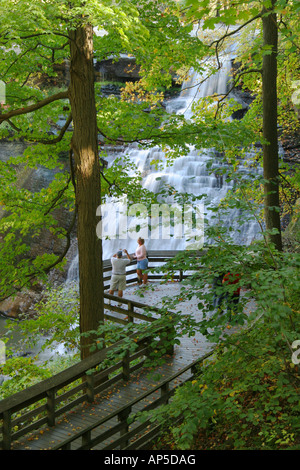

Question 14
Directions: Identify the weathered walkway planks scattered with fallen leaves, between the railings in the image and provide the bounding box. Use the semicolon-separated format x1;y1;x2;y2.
6;283;213;450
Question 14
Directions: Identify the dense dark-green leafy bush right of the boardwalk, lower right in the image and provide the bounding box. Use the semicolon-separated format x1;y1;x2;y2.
141;244;300;449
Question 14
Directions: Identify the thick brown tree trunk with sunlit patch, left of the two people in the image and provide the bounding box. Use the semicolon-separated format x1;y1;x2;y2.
69;24;103;359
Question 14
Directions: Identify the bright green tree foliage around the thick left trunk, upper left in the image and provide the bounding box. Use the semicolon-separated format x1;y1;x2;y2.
0;0;211;299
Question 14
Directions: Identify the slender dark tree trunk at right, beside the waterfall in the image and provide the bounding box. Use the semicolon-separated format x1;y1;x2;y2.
262;0;282;251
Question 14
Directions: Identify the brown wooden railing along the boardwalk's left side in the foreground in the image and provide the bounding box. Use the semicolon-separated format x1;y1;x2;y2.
0;322;173;450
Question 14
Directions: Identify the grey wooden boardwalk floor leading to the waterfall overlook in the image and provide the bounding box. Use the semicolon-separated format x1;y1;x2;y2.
7;285;213;450
